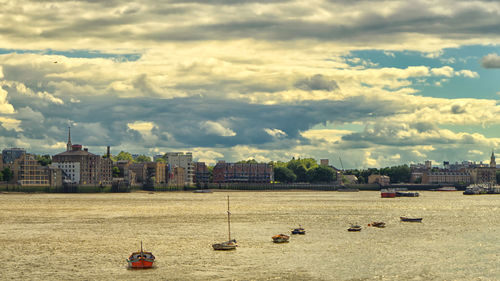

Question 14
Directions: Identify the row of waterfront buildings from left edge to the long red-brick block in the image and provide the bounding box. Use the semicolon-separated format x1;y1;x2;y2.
0;144;274;186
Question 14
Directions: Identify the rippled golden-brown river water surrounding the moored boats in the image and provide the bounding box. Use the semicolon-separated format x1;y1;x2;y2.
0;189;500;280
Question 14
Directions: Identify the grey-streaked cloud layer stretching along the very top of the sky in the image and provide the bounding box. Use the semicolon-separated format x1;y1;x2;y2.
2;0;500;46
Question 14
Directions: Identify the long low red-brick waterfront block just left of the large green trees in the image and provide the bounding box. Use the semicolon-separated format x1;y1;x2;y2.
213;161;274;183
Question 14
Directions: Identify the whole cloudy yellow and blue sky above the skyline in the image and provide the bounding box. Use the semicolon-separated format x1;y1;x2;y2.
0;0;500;168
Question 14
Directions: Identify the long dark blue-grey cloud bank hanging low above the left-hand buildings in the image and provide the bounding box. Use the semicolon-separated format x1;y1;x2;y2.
0;89;402;153
